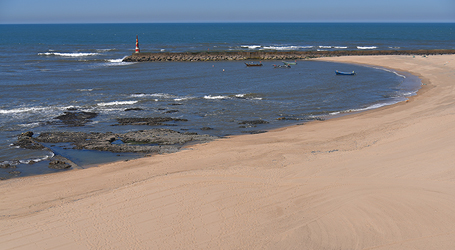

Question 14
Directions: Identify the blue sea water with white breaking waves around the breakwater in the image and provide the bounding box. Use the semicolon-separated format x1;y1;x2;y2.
0;23;455;178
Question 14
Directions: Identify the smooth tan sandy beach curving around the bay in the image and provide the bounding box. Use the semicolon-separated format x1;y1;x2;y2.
0;55;455;249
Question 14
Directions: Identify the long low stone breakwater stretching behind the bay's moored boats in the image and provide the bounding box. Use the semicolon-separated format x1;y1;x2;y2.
123;49;455;62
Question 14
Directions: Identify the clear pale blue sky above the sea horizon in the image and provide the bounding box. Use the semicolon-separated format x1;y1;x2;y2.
0;0;455;24
